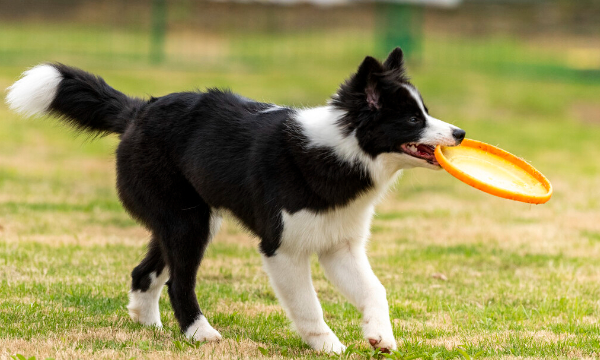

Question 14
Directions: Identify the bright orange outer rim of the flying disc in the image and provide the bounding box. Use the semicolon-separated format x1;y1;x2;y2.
434;139;553;204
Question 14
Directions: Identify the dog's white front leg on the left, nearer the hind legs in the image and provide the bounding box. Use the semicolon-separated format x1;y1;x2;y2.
263;252;346;353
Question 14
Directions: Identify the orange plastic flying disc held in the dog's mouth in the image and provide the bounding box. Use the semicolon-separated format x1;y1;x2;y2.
435;139;552;204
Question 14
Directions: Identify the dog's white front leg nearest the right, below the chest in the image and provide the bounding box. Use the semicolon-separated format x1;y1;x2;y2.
319;241;396;351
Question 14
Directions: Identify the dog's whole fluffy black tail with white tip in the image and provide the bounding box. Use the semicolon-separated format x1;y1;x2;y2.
6;64;147;134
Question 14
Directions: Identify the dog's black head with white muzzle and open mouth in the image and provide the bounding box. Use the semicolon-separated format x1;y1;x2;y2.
331;48;465;169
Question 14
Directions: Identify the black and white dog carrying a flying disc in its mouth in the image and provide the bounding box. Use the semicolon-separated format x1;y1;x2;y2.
6;48;465;353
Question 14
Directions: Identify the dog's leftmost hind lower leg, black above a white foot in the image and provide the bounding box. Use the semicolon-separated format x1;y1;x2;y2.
127;238;169;327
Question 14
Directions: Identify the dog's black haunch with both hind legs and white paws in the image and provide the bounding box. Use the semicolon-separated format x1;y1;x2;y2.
117;142;221;341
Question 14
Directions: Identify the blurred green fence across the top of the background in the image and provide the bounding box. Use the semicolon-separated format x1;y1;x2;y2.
0;0;600;81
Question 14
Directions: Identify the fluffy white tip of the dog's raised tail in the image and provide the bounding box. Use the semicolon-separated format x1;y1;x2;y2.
6;64;62;116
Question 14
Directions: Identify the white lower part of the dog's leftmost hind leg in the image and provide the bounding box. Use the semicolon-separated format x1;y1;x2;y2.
127;267;169;327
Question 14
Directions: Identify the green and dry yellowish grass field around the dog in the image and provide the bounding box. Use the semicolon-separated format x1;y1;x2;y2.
0;26;600;359
